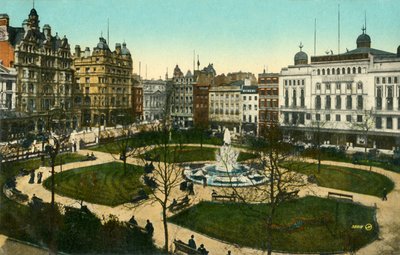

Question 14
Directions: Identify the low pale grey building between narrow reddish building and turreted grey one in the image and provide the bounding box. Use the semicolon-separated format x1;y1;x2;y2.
142;79;167;121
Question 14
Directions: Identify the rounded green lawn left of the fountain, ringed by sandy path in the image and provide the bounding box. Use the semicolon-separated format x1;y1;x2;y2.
43;162;147;206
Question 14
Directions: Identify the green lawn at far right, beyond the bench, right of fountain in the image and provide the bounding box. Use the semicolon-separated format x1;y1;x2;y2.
288;162;394;197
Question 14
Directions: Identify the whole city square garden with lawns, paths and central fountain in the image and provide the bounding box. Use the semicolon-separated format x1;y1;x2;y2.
0;126;400;254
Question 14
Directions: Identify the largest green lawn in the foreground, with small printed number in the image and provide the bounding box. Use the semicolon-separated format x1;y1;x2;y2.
169;197;378;253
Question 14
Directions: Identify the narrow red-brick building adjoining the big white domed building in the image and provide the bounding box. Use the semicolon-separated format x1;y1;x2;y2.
258;72;279;134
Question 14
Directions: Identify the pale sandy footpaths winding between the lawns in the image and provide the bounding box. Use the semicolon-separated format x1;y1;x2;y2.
8;145;400;255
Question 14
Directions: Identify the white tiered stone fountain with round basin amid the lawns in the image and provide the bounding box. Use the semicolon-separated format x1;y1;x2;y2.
184;128;266;187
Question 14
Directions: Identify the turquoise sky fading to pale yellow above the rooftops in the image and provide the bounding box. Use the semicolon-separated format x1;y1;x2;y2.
0;0;400;79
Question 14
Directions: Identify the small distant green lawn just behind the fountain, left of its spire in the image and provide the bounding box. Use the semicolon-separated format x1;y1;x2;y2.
147;146;217;163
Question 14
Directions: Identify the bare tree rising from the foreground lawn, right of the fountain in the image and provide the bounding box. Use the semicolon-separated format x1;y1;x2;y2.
227;126;307;254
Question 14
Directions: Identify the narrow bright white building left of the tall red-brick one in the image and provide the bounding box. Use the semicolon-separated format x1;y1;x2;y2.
240;79;258;135
